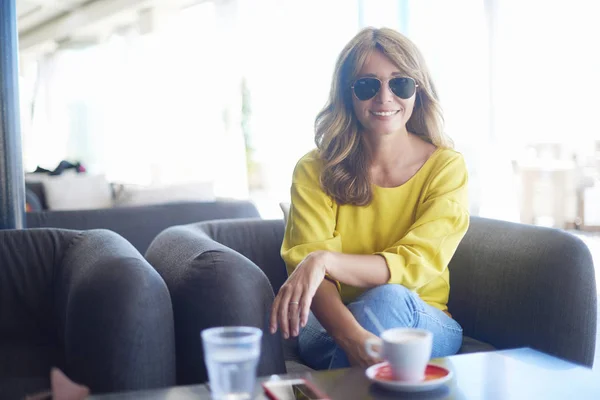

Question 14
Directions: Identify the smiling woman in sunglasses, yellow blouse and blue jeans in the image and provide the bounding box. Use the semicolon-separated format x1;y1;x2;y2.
270;28;469;369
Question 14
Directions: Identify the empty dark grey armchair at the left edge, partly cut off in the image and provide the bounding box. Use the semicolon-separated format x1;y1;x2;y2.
0;229;175;399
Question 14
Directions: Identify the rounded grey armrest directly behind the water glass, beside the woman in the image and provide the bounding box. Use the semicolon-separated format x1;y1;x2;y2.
146;224;285;385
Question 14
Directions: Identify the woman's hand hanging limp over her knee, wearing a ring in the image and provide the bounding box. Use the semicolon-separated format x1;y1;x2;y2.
270;251;327;339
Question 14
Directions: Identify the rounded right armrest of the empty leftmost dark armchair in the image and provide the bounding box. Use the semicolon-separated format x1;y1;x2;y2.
55;230;175;392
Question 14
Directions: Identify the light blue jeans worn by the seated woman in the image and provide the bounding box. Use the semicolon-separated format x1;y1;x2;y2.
298;284;462;369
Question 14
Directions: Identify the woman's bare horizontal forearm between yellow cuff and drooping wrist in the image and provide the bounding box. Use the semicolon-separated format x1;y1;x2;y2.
322;251;390;288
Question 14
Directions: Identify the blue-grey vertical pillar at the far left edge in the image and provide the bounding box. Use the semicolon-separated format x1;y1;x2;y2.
0;0;25;229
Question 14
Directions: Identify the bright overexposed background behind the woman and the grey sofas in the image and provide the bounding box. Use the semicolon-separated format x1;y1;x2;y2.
17;0;600;225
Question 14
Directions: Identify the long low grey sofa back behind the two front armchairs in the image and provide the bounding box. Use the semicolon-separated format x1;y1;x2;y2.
27;200;260;254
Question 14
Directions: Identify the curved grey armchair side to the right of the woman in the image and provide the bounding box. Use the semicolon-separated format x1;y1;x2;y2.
449;217;597;366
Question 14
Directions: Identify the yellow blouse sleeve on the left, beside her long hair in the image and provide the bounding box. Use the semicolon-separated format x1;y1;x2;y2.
281;155;342;290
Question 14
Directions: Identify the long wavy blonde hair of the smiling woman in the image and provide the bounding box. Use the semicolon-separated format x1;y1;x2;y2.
315;28;452;206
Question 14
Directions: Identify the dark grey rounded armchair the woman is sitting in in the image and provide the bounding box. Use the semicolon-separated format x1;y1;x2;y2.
146;217;597;384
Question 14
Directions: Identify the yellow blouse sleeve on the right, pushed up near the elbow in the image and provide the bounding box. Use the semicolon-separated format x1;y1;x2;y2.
375;154;469;290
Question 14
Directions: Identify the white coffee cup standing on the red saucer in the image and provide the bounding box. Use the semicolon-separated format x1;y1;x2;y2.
365;328;433;382
